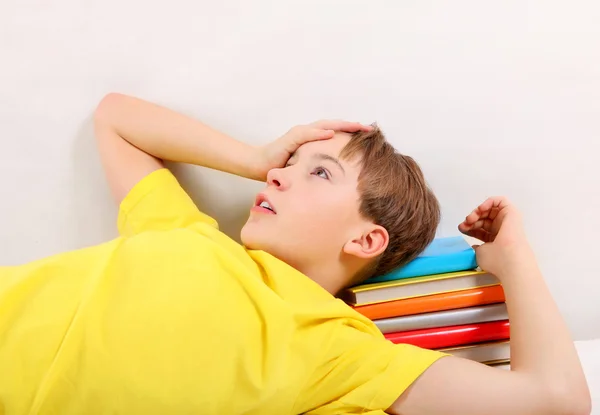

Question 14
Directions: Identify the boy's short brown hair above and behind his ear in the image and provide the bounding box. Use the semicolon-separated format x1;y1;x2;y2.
340;124;441;284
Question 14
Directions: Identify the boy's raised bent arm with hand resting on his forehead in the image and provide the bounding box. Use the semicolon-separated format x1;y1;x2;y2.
94;93;371;206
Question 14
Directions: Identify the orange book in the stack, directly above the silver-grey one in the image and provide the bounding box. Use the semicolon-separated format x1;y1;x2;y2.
354;285;504;320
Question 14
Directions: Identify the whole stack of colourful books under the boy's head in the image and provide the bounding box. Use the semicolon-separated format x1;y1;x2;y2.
341;236;510;369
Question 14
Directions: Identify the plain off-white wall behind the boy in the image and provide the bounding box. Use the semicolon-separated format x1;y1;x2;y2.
0;0;600;339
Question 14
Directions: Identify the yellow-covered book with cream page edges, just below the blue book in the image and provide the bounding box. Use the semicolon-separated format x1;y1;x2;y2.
340;270;500;305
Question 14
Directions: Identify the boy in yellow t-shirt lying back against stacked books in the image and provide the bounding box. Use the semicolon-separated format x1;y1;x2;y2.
0;94;590;415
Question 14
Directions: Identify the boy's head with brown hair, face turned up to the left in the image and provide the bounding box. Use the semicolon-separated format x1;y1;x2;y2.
241;127;440;292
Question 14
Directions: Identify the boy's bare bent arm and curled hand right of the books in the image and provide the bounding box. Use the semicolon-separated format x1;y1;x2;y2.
389;198;591;415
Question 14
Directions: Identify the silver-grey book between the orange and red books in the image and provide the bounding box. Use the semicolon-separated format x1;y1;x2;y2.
373;303;508;333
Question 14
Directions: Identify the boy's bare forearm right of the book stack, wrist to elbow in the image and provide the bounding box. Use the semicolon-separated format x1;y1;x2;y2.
503;247;589;406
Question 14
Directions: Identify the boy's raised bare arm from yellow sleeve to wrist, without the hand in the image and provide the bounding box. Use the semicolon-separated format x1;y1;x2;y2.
94;93;255;206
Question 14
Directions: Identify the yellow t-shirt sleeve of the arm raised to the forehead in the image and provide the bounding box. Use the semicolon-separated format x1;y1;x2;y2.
117;168;218;236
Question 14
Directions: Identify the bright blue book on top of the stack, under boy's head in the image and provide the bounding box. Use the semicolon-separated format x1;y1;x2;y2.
366;236;477;284
